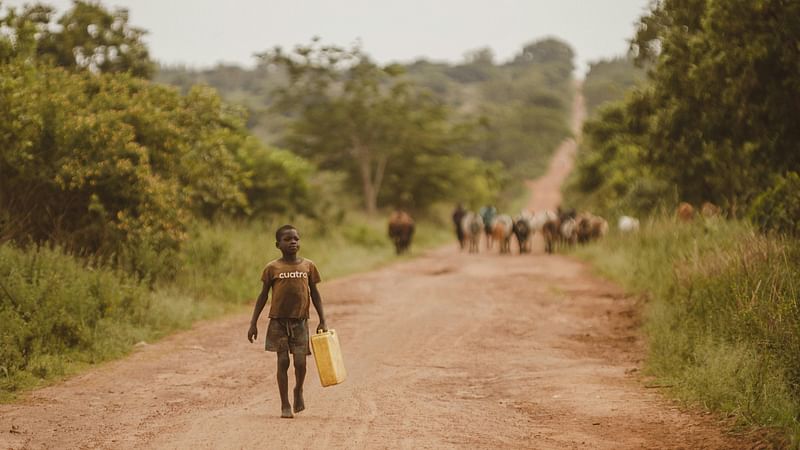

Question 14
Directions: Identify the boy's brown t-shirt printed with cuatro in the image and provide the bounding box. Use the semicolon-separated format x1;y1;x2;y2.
261;258;320;319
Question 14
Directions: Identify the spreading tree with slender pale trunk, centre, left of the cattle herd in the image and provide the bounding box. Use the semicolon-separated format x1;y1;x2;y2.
259;39;478;213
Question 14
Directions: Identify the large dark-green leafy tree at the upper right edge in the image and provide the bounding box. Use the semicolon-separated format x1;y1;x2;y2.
568;0;800;222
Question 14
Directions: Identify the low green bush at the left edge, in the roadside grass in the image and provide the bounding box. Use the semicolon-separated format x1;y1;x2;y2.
0;243;150;390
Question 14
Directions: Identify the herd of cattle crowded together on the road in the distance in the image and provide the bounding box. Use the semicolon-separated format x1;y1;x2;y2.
460;207;608;254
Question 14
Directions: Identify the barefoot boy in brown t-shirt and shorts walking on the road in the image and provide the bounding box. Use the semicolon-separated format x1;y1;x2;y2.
247;225;328;419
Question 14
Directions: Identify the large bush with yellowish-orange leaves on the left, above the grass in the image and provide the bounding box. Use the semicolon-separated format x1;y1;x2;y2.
0;62;253;276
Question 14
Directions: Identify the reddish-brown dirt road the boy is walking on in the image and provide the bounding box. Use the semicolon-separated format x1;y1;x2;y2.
0;89;738;449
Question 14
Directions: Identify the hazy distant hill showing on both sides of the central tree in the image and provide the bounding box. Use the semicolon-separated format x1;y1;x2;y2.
155;38;574;178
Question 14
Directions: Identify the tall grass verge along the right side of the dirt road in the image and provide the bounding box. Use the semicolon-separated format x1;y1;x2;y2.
577;218;800;446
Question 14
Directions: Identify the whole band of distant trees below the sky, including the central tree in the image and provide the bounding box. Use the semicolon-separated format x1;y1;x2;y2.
156;39;574;204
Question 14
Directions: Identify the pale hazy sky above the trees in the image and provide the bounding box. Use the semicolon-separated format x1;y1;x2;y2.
0;0;650;76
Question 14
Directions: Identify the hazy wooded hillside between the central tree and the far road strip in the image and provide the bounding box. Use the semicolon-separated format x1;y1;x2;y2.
407;39;574;179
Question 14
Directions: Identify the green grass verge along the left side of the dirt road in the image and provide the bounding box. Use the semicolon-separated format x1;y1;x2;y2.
0;213;455;401
